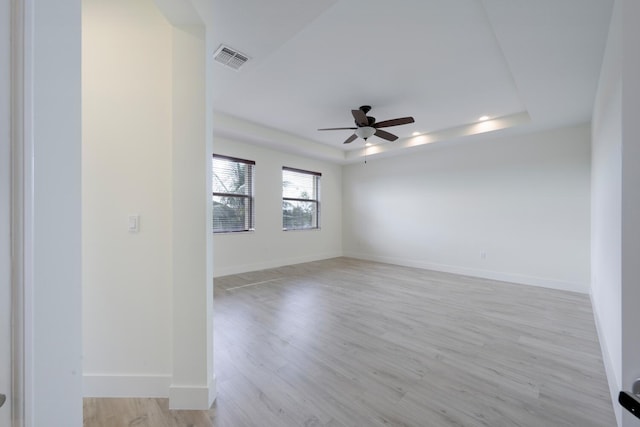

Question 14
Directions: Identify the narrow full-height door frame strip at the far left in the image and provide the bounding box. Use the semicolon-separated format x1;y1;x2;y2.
10;0;34;427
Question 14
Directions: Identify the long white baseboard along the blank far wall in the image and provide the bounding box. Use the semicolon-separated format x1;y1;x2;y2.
344;252;589;294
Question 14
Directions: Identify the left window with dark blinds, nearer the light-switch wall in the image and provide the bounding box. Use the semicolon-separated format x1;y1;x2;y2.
212;154;256;233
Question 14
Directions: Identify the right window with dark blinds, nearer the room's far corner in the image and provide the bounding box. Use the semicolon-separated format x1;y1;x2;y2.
282;167;322;230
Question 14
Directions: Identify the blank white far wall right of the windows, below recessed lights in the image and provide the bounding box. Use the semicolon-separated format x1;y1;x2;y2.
343;126;590;292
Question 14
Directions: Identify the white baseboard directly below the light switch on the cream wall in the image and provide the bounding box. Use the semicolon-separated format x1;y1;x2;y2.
82;374;171;397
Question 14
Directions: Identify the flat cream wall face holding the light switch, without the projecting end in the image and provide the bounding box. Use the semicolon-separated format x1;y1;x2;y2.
82;0;172;397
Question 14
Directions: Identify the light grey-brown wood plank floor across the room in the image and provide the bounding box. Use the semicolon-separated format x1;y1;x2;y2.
84;258;615;427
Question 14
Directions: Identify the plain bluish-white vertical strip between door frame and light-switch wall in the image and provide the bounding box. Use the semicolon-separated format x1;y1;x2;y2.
32;0;82;426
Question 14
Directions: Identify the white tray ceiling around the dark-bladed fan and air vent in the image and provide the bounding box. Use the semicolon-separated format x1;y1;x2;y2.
213;0;612;161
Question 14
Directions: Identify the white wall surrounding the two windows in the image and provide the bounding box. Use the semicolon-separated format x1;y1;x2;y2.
213;137;342;276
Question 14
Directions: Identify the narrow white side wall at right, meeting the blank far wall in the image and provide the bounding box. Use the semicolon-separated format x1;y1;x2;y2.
591;2;622;421
